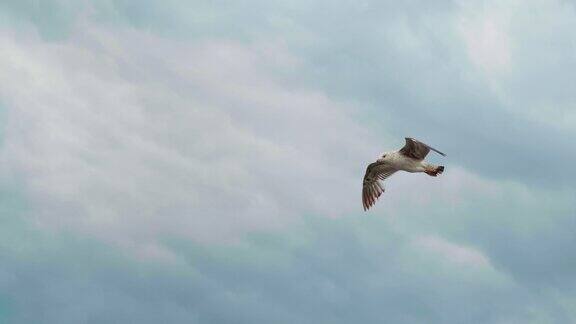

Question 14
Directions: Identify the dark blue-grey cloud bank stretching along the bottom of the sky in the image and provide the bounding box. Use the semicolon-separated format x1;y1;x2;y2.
0;208;567;323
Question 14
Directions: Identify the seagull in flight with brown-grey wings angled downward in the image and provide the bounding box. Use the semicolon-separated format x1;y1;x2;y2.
362;137;446;211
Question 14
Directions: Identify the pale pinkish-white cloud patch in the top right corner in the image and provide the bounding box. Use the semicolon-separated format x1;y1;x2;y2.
457;0;576;131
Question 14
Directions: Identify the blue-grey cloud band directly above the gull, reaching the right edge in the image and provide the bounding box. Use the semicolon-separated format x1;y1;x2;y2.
288;0;576;187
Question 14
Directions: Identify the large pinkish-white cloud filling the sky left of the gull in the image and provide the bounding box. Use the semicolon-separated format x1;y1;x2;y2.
0;26;372;250
